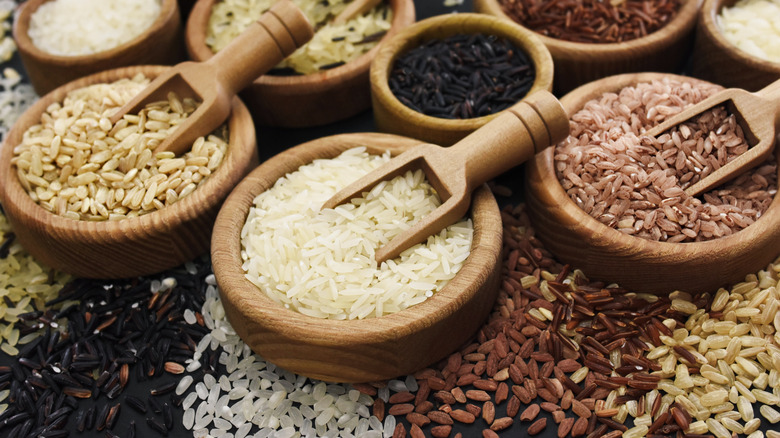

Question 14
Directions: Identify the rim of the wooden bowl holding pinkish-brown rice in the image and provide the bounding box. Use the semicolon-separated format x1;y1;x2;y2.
530;72;780;258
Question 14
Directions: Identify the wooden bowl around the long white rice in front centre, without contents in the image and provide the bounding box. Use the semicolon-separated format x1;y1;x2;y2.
211;133;501;382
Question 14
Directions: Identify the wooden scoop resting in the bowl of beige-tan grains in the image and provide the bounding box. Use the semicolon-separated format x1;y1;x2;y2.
111;0;314;155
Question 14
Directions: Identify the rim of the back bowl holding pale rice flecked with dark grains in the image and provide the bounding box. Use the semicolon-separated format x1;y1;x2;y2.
185;0;415;94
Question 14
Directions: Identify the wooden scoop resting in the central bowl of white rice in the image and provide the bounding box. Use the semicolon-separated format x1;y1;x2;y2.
323;91;569;263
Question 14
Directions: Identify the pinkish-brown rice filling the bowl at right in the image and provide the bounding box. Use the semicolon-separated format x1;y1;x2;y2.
555;78;777;242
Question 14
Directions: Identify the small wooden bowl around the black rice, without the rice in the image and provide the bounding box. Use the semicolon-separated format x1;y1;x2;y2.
371;13;553;146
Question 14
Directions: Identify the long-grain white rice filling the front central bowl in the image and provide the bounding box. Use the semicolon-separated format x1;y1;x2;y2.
241;148;473;319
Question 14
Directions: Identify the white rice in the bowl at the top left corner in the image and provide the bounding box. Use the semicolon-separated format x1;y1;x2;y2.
28;0;161;56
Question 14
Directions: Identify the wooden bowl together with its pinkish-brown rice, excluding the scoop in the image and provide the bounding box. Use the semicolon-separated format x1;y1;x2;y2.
526;73;780;293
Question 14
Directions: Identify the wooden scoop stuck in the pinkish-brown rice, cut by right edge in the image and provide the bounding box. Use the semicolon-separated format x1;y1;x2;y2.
645;80;780;196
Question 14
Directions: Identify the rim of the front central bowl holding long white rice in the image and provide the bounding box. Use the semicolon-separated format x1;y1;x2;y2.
211;133;502;348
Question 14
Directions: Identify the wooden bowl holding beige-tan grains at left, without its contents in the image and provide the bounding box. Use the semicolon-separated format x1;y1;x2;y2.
0;66;259;278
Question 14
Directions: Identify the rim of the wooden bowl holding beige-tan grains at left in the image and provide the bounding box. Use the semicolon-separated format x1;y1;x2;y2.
0;65;254;248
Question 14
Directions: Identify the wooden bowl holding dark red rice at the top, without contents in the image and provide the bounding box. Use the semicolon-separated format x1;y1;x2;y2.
474;0;699;95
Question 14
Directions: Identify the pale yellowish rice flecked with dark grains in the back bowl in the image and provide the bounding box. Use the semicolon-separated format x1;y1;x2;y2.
206;0;392;74
